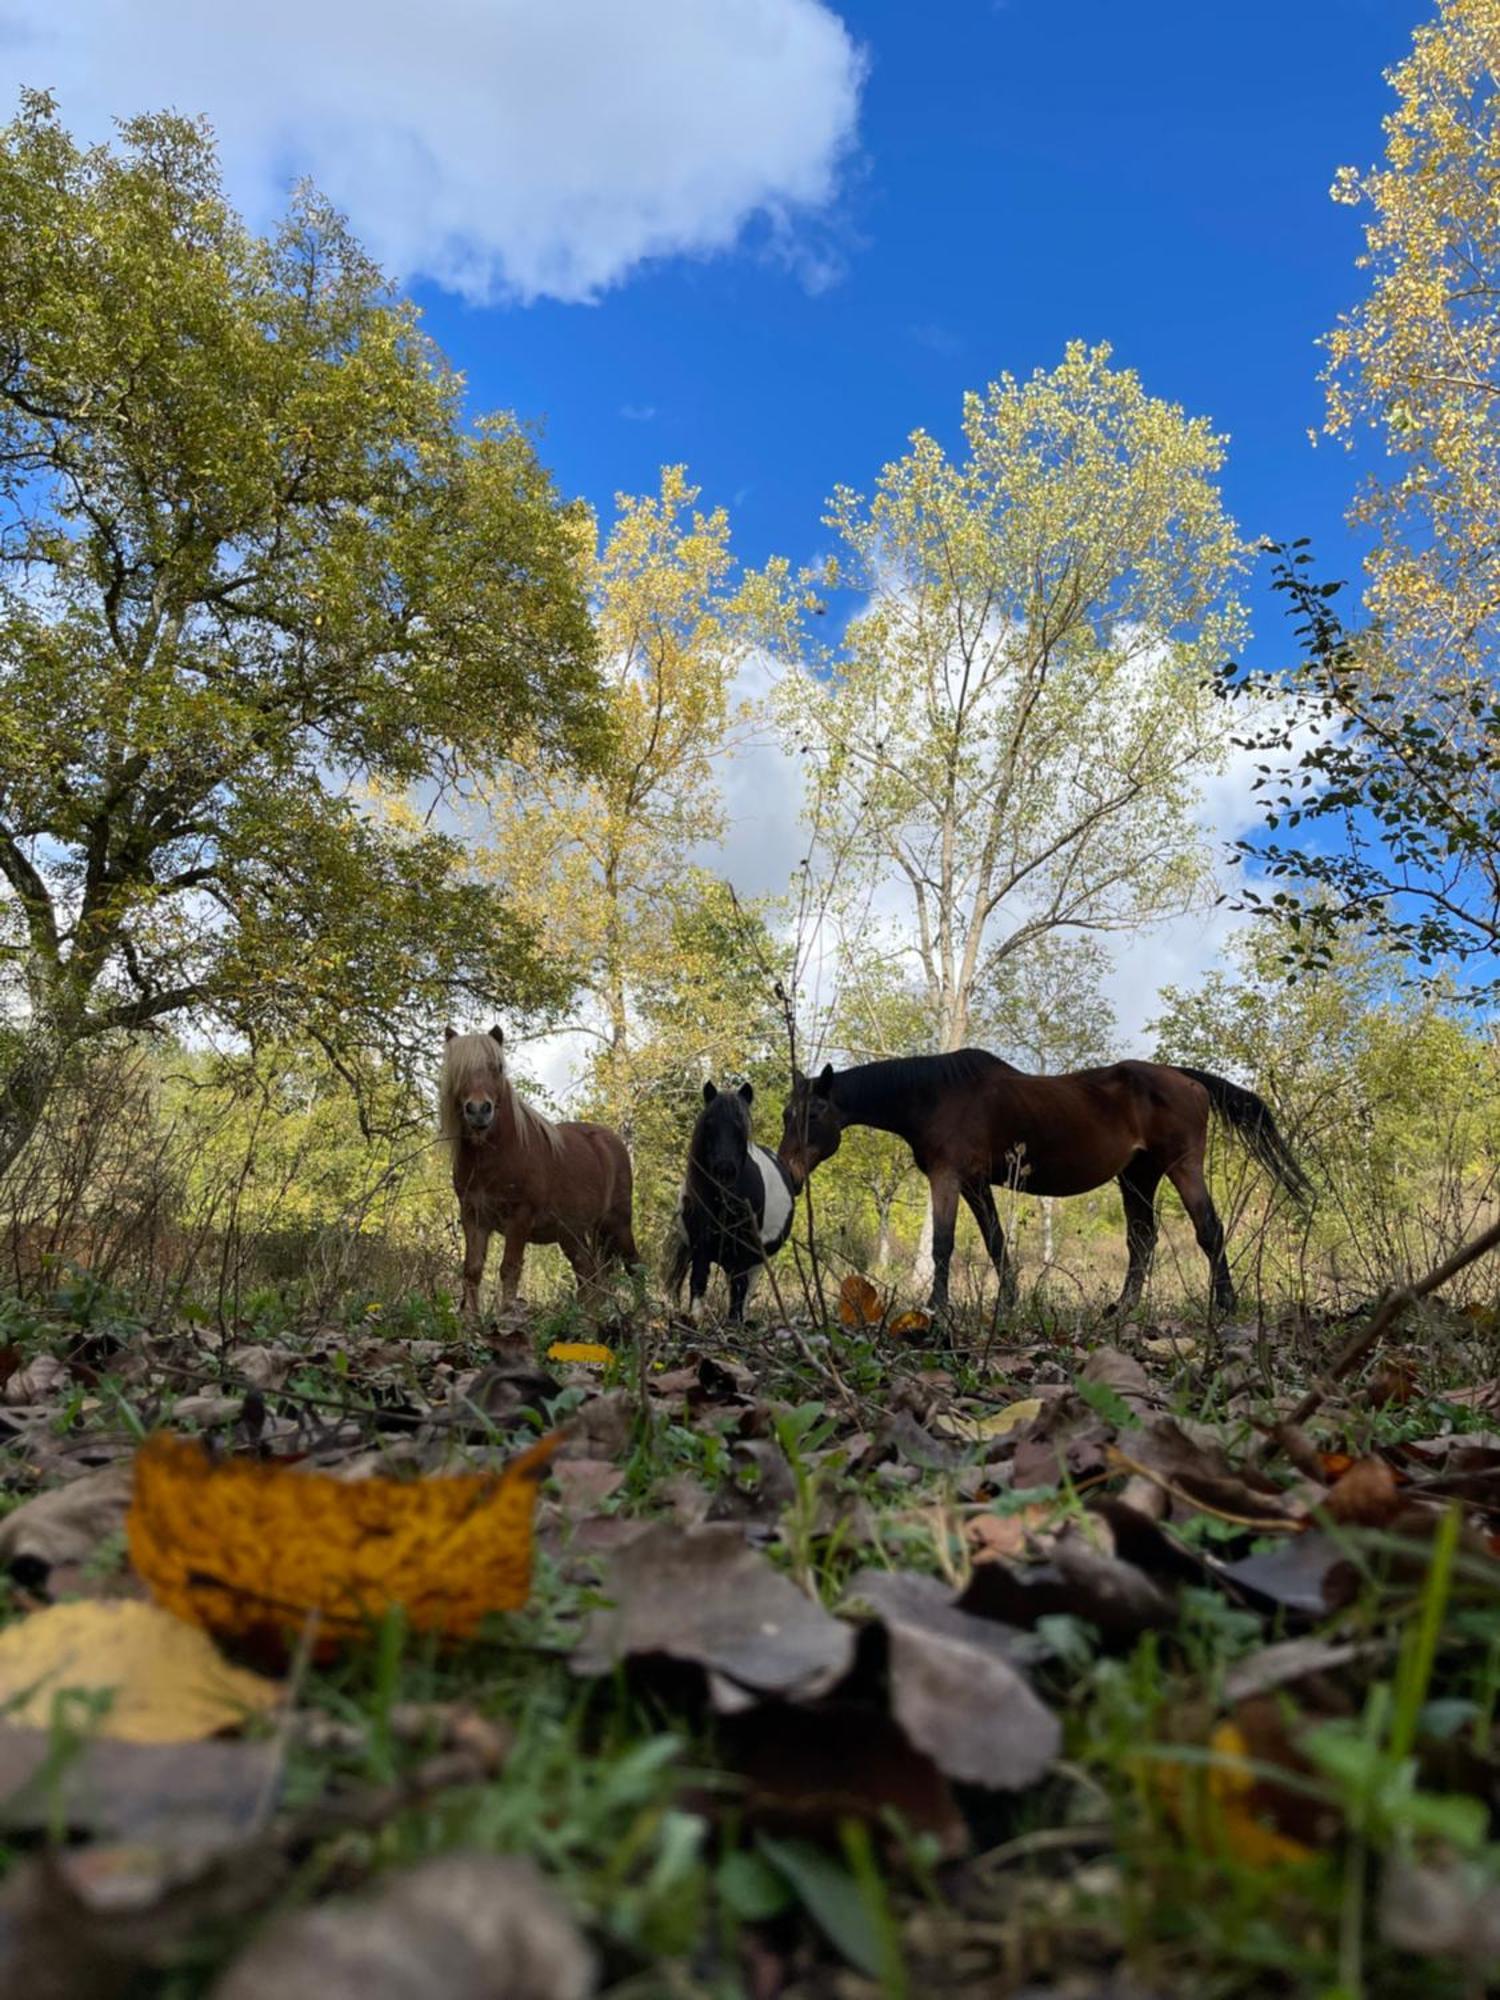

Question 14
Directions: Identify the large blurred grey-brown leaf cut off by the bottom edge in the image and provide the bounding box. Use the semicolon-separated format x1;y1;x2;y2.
214;1854;594;2000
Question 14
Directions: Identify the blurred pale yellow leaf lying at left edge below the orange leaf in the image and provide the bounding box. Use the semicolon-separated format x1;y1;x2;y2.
0;1598;282;1744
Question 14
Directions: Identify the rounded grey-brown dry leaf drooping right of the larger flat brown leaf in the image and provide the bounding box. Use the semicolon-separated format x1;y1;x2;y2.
850;1570;1062;1792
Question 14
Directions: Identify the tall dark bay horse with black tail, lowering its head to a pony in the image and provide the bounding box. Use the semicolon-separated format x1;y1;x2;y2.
780;1048;1308;1312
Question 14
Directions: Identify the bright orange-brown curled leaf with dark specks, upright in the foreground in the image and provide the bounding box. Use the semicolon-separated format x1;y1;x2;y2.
126;1434;560;1644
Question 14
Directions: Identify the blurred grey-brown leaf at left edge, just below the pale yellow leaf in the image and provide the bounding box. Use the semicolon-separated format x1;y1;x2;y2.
0;1724;282;1844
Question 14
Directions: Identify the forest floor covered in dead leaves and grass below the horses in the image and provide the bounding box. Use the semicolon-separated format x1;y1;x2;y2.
0;1278;1500;2000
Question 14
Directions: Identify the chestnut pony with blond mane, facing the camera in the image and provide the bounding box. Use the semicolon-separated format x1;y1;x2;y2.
438;1028;640;1314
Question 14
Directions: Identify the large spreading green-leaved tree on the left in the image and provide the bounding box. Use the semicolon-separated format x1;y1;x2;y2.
0;96;604;1168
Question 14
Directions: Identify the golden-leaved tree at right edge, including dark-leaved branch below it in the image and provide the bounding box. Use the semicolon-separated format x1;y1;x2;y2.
1232;0;1500;1000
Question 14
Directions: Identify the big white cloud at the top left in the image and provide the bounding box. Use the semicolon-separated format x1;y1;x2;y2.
0;0;864;300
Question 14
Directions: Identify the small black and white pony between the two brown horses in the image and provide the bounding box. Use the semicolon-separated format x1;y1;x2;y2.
666;1084;796;1320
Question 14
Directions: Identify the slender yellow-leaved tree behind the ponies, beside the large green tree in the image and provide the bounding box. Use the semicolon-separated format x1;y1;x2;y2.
484;466;788;1184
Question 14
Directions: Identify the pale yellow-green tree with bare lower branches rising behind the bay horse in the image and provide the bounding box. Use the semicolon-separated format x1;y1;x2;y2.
772;344;1240;1048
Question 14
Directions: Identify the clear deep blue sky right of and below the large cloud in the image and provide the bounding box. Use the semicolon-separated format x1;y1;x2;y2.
418;0;1430;664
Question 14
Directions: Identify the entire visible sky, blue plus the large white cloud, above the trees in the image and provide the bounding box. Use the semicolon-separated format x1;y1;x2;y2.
0;0;1432;1056
